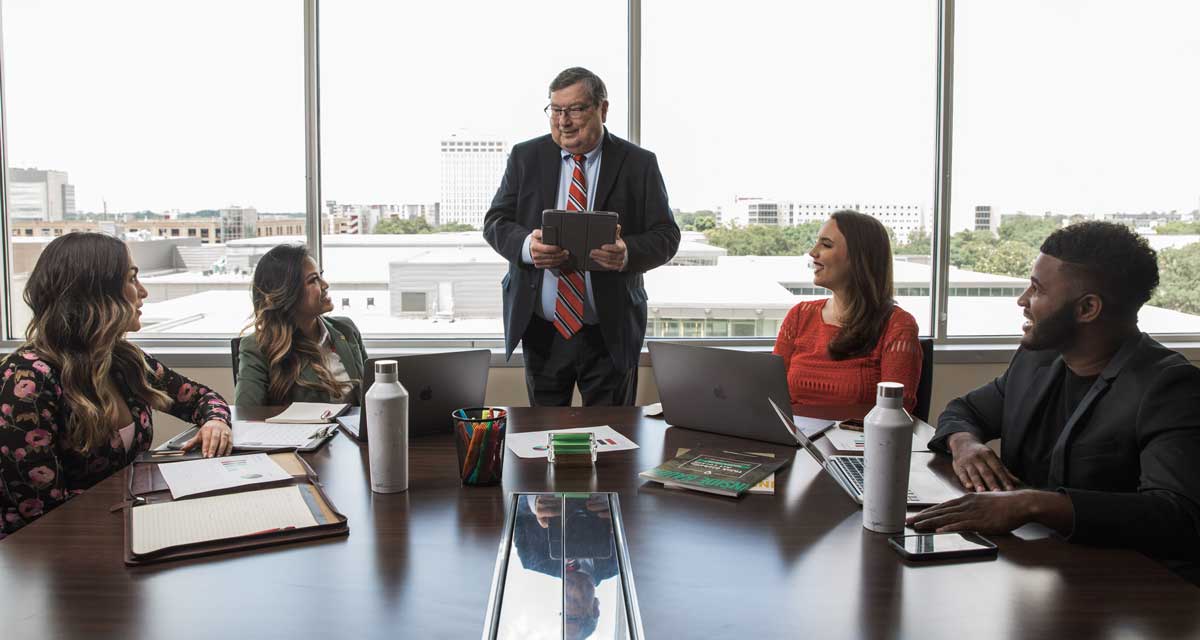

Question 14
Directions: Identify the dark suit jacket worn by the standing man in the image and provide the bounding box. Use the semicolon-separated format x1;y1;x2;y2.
484;130;679;369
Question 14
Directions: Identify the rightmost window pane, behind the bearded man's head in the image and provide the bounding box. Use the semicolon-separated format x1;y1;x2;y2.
948;0;1200;335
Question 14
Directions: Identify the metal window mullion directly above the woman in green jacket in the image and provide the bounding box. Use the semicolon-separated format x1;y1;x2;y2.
304;0;324;268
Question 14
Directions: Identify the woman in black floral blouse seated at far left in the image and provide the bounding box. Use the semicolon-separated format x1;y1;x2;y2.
0;233;233;539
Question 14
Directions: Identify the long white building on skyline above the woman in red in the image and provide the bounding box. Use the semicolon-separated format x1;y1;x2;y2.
718;197;928;243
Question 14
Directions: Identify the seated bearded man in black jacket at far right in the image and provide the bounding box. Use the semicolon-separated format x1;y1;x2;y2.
908;222;1200;584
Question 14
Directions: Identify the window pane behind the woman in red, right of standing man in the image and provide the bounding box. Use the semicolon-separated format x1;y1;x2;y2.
641;0;937;337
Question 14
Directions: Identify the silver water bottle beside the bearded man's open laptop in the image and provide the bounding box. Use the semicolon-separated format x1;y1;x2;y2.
863;382;912;533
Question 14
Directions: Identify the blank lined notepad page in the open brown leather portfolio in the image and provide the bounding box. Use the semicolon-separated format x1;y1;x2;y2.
130;485;317;554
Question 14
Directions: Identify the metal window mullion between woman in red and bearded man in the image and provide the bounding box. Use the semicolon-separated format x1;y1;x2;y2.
930;0;954;341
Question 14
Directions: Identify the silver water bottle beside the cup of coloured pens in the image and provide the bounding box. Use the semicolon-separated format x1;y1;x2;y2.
362;360;408;494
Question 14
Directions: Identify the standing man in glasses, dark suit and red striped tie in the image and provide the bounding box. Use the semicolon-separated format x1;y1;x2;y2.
484;67;679;406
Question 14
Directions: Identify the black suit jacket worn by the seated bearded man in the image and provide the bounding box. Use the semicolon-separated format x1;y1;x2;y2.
930;334;1200;581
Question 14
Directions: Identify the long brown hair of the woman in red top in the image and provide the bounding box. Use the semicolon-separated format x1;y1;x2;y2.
829;210;895;360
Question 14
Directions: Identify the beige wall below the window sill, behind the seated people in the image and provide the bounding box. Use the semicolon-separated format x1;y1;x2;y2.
145;363;1027;445
